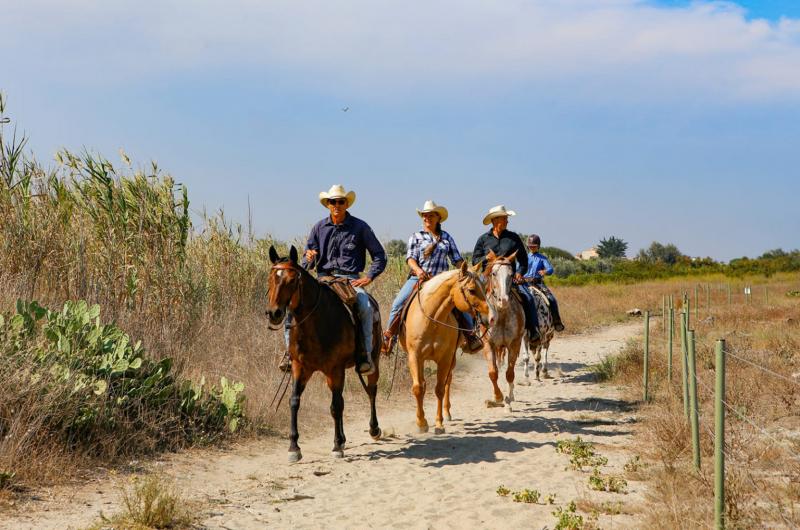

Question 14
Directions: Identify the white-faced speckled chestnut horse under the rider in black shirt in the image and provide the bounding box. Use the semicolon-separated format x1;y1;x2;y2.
483;251;525;408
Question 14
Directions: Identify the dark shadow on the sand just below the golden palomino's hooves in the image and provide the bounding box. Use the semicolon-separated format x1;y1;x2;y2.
365;429;555;468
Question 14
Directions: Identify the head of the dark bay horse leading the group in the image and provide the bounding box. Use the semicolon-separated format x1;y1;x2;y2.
266;245;304;329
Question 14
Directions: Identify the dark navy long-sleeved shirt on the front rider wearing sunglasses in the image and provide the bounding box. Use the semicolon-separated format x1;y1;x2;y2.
306;213;386;280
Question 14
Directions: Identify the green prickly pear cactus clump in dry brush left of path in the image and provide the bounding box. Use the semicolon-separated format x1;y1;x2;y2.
0;300;244;450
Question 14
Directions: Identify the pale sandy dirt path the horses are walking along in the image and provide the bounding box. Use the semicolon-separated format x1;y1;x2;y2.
0;323;643;529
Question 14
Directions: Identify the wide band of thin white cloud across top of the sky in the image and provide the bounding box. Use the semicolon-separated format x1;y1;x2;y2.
0;0;800;101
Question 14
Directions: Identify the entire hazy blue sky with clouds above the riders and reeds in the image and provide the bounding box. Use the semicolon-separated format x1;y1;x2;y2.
0;0;800;260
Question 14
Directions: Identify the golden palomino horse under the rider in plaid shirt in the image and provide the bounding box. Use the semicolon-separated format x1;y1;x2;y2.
400;263;490;434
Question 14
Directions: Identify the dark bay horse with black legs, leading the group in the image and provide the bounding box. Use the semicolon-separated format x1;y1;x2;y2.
267;247;381;462
